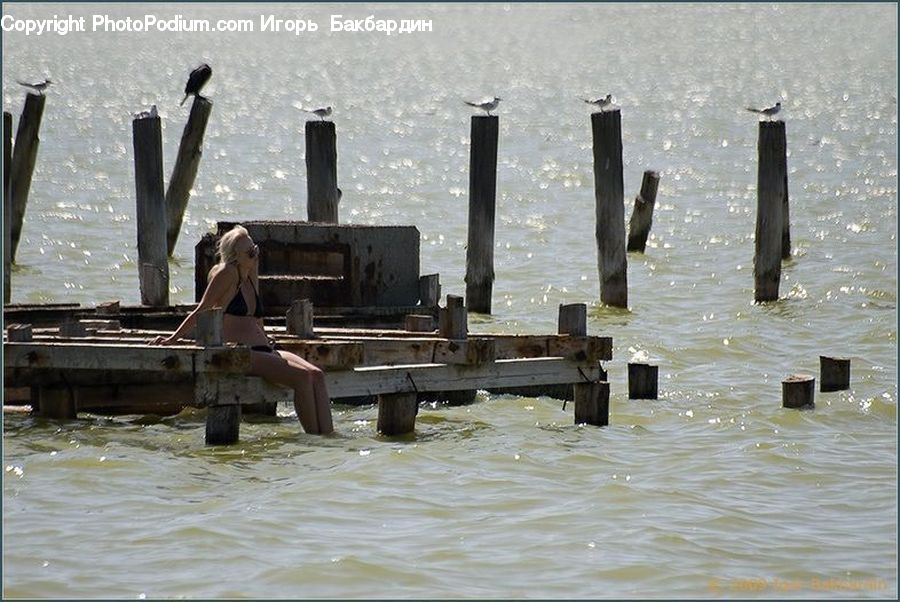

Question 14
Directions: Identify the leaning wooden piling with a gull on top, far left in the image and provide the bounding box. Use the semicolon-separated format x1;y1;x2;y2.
9;94;47;262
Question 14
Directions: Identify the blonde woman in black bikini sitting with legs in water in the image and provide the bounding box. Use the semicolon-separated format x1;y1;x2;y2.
151;226;334;435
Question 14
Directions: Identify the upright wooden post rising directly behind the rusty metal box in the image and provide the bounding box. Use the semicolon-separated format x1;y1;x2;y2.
306;121;340;224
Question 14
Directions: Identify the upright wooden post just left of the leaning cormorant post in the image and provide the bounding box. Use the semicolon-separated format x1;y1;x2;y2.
132;116;169;307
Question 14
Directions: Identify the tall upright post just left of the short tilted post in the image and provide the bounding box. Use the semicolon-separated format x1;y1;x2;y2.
591;109;628;307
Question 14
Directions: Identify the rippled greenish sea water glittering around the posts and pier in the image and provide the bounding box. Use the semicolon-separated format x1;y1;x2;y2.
3;4;897;598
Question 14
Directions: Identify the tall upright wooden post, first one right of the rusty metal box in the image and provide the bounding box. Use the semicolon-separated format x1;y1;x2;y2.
465;115;500;314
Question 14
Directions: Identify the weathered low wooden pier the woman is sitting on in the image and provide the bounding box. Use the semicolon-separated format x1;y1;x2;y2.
3;302;612;443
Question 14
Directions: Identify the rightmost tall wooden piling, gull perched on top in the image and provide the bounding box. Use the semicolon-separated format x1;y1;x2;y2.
753;121;790;303
